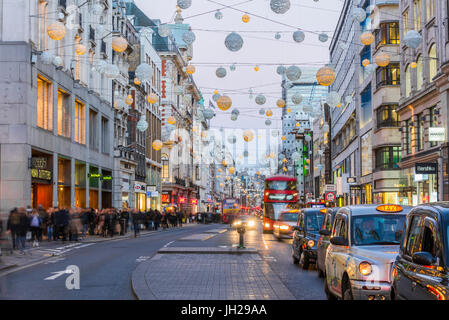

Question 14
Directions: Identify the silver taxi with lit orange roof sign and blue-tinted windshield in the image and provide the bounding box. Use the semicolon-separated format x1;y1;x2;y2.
324;205;411;300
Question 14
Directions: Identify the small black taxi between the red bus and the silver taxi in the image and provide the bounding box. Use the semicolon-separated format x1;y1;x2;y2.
292;208;324;270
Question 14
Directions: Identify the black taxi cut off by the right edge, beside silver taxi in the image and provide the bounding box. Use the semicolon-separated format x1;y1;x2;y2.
391;202;449;300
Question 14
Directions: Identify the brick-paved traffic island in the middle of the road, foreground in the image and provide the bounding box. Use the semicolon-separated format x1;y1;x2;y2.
132;252;295;300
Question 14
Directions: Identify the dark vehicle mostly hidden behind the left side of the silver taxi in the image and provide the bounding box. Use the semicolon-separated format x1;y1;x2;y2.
316;208;339;278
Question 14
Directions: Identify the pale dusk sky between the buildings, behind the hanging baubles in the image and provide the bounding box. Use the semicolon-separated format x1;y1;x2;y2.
135;0;344;170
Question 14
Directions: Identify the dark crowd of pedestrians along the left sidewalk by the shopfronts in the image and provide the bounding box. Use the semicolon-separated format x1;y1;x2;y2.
6;206;193;254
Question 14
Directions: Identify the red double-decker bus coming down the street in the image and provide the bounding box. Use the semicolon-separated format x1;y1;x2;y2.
263;175;298;233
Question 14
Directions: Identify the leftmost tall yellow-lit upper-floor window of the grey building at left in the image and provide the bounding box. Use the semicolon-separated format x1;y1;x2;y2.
36;77;53;130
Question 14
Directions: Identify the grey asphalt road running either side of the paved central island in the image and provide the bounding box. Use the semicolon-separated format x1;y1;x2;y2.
0;220;325;300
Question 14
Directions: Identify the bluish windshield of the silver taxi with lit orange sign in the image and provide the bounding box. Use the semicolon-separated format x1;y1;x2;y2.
352;215;405;246
